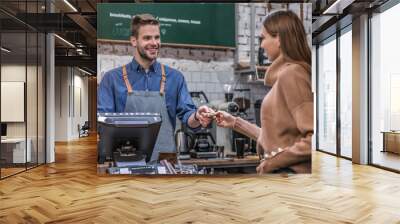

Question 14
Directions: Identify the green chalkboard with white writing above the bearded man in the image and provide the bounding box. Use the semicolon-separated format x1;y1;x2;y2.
97;3;235;47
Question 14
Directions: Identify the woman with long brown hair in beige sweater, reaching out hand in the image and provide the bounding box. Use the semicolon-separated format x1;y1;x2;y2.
216;11;313;173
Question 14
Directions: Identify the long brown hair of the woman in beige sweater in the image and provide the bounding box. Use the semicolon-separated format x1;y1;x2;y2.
263;11;311;72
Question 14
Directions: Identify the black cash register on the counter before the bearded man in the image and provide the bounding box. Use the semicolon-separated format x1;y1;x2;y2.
97;113;162;174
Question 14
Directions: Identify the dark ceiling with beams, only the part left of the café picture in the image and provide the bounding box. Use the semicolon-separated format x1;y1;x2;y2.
0;0;99;75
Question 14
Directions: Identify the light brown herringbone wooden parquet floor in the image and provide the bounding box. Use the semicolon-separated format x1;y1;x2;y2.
0;138;400;224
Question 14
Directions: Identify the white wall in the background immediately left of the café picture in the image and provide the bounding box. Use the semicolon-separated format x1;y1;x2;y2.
55;67;88;141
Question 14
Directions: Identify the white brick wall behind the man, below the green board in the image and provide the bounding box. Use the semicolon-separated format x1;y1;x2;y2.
97;44;267;119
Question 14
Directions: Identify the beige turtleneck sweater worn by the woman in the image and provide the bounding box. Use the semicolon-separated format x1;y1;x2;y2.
234;57;314;173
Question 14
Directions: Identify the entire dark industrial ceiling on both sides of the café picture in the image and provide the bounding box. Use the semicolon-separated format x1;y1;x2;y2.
0;0;394;74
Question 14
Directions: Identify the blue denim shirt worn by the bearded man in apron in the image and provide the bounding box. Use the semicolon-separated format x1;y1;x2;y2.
97;59;196;129
